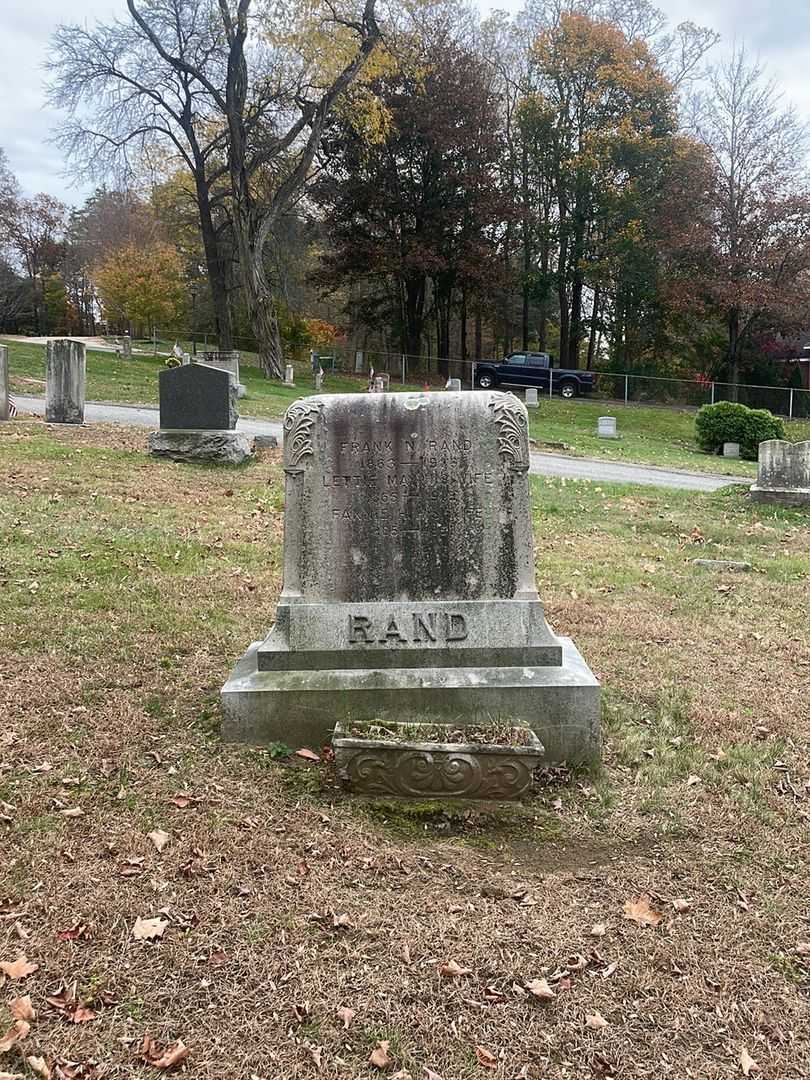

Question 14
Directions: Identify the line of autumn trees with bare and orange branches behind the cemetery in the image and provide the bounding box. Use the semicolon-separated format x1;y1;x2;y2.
0;0;810;381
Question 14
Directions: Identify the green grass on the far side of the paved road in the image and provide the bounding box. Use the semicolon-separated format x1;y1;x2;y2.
9;332;810;476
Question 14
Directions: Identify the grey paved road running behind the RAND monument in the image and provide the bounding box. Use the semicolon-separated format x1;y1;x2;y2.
14;394;751;491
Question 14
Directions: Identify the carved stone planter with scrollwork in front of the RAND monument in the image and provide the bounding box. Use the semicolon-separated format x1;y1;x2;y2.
332;721;544;802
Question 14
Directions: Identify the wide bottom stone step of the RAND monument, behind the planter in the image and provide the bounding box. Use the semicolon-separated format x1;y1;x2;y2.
220;637;600;766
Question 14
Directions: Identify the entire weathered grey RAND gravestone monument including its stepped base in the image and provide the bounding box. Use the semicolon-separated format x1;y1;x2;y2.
222;391;599;764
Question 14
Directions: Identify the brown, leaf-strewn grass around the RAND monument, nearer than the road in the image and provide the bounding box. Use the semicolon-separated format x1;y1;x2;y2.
0;421;810;1080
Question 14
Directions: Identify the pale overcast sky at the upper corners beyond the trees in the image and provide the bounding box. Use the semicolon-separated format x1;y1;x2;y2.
0;0;810;203
